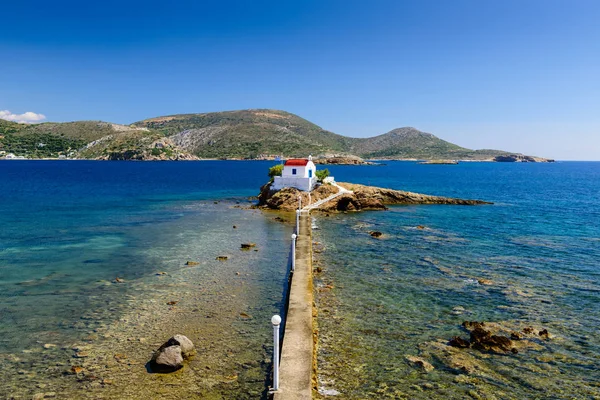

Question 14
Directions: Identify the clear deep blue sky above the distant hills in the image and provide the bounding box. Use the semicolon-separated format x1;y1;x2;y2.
0;0;600;160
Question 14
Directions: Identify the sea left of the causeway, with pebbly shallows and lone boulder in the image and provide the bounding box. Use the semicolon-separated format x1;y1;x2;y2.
0;161;291;398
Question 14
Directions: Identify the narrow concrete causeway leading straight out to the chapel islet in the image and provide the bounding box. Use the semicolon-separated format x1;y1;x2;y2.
273;211;314;400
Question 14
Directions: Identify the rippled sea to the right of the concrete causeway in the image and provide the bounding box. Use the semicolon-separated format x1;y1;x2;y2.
315;162;600;399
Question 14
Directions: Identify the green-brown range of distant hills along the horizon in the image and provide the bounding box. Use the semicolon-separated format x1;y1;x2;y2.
0;109;552;161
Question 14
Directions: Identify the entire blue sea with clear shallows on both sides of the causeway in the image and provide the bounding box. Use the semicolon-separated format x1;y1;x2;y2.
0;161;600;399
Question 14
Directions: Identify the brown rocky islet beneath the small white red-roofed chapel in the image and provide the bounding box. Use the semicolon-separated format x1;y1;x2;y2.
258;183;492;212
